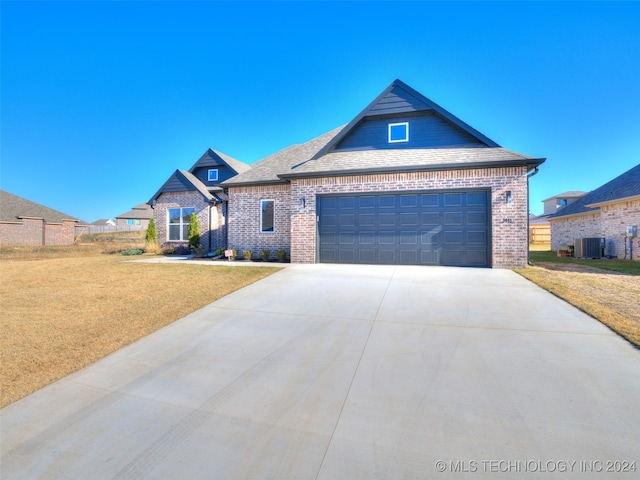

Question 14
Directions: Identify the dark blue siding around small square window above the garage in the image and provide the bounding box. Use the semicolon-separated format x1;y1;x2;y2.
335;112;485;150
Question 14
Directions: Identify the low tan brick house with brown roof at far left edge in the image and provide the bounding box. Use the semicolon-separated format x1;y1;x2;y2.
0;190;84;247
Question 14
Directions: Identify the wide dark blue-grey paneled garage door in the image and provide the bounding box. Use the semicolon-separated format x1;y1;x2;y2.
318;190;490;267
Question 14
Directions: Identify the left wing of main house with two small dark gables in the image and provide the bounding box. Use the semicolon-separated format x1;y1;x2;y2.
148;149;250;252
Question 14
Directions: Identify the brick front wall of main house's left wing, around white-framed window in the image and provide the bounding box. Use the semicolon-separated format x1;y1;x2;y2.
153;192;227;252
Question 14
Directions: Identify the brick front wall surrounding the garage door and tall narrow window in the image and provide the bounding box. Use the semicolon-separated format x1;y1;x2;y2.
229;167;528;268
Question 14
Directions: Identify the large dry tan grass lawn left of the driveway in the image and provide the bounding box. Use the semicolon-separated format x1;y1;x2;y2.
0;247;278;406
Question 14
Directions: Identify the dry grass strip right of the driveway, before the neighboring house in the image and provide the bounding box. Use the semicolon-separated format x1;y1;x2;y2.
516;252;640;346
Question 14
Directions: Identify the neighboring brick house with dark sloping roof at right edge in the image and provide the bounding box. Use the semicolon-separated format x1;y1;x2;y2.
549;165;640;260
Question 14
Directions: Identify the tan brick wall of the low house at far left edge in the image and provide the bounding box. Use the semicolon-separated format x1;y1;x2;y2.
0;218;76;246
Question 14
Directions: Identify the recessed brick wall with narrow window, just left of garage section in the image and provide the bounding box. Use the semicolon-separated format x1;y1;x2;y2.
229;184;292;256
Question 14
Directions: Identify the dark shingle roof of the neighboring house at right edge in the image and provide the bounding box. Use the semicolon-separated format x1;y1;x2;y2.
549;164;640;219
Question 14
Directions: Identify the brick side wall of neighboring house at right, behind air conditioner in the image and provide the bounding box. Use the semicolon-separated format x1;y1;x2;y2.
549;199;640;260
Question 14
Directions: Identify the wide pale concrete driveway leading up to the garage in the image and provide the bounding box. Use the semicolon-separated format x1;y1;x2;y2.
0;265;640;480
